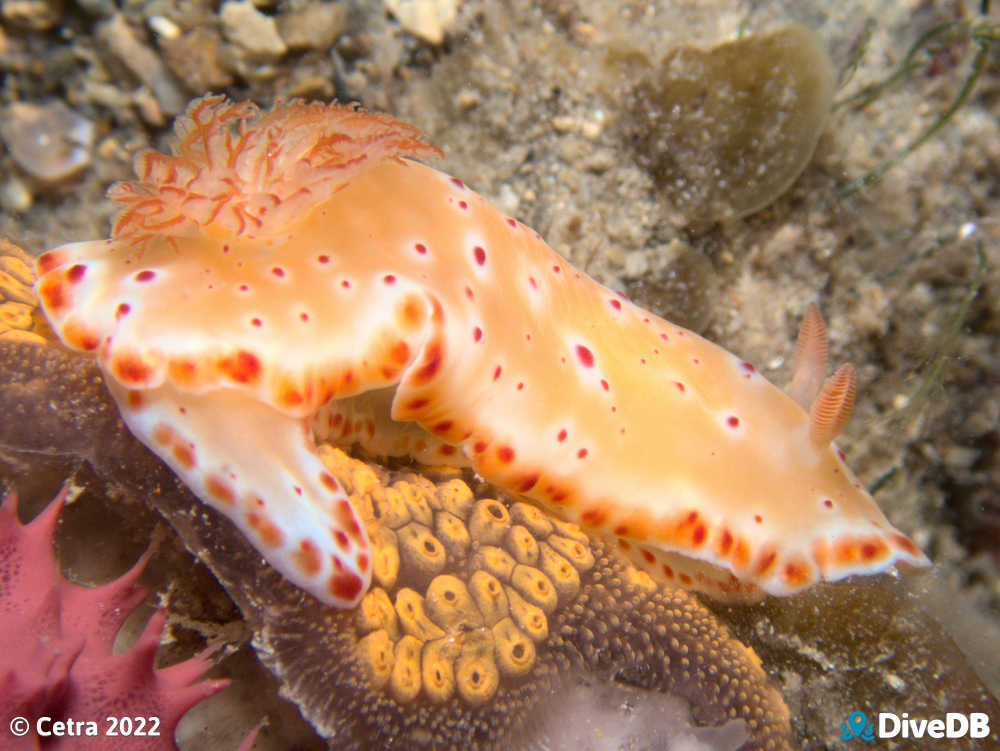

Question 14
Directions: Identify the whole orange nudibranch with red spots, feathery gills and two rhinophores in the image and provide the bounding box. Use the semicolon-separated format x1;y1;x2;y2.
36;97;927;607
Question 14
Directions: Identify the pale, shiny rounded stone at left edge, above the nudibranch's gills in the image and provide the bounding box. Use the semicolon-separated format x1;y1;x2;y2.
0;101;94;183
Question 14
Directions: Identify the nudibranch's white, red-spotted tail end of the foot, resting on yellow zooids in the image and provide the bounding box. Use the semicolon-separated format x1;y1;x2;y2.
105;376;372;607
